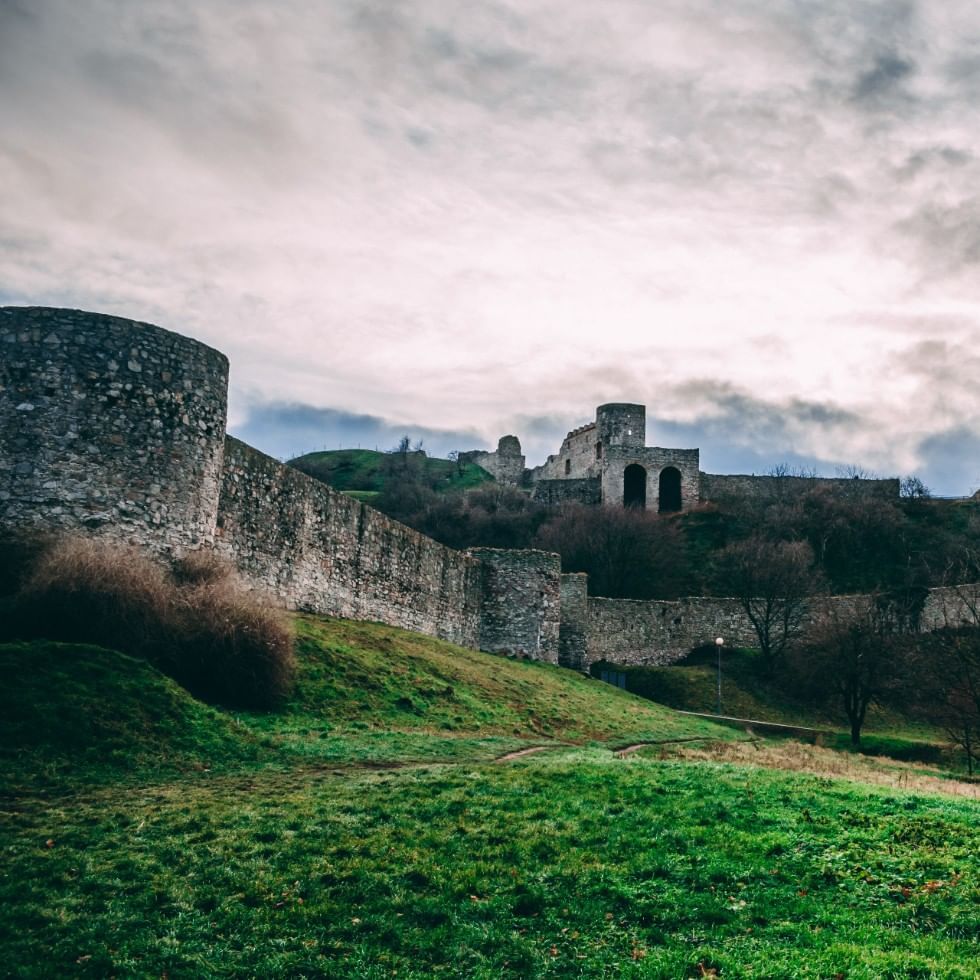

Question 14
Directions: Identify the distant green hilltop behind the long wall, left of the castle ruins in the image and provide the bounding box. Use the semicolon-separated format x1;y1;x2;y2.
289;449;493;502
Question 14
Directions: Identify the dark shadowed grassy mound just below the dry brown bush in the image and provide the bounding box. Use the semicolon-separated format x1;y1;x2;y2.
0;641;272;791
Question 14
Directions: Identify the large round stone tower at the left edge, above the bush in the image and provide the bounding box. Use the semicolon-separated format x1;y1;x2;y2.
0;307;228;551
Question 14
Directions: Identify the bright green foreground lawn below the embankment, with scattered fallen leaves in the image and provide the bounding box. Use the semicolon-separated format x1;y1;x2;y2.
0;750;980;980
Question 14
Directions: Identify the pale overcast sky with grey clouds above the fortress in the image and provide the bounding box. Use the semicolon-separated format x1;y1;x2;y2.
0;0;980;494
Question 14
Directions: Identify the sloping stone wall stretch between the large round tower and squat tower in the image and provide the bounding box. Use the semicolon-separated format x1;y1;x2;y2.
216;436;483;647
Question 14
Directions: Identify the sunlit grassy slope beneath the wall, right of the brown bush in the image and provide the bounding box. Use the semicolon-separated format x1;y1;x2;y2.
239;616;730;759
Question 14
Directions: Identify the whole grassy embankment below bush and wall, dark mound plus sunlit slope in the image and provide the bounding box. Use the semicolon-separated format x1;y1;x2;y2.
0;617;735;787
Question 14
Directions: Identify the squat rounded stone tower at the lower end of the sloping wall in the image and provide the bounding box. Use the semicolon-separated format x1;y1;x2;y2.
468;548;561;664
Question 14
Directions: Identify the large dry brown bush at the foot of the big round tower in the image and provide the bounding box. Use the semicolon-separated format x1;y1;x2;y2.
7;536;294;708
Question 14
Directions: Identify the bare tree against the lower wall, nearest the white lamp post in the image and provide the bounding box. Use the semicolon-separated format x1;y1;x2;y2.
722;536;819;670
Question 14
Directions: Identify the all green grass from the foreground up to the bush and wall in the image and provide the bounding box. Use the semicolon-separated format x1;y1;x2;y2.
0;617;980;980
